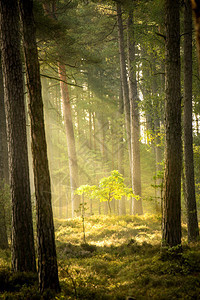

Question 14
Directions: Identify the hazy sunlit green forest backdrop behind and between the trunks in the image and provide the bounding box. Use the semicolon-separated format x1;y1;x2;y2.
36;1;199;218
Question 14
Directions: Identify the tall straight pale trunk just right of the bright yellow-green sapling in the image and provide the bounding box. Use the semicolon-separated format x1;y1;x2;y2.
127;11;143;215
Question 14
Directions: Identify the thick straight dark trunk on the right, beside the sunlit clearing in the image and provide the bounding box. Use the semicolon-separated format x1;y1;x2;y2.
162;0;182;247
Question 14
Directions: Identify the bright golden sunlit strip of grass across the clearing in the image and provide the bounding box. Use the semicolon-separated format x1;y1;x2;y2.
55;214;161;246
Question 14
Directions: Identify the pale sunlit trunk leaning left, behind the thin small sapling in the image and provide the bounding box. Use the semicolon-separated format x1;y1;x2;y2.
58;63;80;218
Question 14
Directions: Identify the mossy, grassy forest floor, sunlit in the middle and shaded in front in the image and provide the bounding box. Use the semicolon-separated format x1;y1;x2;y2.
0;214;200;300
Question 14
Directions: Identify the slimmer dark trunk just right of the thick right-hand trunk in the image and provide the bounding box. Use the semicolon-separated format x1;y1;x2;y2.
184;0;199;242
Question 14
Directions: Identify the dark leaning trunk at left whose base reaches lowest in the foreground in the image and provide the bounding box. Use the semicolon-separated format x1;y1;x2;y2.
20;0;60;292
